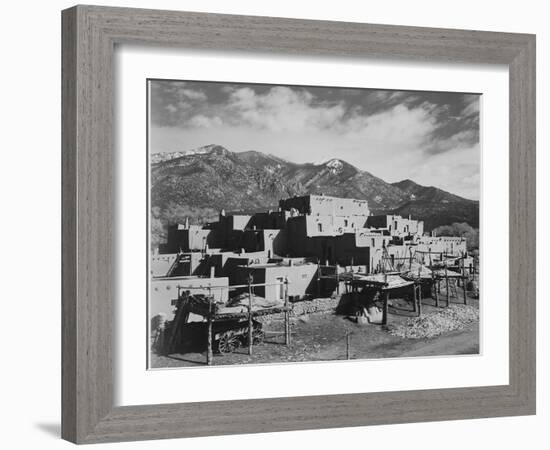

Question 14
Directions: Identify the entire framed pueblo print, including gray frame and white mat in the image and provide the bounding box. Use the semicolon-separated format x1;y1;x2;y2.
62;6;535;443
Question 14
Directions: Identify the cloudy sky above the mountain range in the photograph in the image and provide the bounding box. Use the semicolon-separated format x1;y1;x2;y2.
150;80;480;199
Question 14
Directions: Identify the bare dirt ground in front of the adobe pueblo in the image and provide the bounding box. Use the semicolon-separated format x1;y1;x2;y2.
151;298;479;368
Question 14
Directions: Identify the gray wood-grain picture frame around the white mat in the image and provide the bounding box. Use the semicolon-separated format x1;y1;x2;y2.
62;6;535;443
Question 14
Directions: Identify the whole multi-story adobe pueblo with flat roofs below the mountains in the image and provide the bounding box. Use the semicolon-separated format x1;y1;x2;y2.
150;195;472;319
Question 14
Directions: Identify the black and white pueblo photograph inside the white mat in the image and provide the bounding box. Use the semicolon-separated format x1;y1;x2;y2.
146;79;482;369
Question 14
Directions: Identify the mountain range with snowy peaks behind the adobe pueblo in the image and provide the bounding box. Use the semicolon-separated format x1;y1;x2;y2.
151;145;479;231
